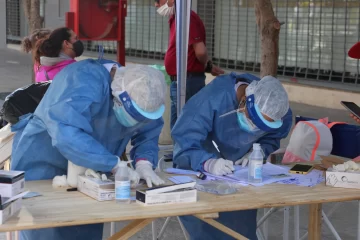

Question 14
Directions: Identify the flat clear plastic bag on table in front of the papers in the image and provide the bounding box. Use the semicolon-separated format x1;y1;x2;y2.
195;180;237;195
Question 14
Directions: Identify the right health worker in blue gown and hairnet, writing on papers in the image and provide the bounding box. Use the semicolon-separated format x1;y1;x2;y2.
171;73;292;240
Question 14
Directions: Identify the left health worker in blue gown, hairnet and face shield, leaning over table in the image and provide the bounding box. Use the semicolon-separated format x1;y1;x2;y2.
11;59;166;240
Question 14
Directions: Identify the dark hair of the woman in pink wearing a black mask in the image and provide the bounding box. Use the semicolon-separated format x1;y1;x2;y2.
34;27;71;62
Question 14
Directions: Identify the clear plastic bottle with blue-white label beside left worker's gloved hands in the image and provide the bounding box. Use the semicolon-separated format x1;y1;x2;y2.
115;161;130;203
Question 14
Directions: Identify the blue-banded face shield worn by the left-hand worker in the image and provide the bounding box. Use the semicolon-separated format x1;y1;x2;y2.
114;91;165;122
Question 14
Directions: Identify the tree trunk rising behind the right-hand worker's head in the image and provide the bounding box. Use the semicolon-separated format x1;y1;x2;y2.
255;0;281;77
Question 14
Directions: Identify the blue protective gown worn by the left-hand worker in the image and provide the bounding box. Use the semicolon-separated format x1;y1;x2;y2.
11;60;163;240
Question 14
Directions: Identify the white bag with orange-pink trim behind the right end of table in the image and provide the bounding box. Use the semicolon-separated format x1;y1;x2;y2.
282;119;333;163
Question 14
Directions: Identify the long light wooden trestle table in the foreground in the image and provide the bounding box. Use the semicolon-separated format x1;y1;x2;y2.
0;176;360;240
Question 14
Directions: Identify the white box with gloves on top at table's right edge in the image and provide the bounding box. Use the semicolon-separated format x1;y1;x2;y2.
326;168;360;189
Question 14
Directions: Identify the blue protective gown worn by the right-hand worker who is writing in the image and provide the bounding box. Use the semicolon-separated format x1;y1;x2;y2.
171;73;292;240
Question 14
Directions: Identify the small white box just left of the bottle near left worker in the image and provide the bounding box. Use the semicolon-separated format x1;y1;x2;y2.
77;175;115;202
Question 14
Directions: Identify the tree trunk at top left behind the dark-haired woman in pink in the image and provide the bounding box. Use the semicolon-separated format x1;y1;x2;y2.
22;0;44;83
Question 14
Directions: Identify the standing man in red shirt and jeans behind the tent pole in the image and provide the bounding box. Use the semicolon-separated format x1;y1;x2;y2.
155;0;224;129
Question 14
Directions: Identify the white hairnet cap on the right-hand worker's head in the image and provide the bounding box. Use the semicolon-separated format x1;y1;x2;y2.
246;76;289;121
